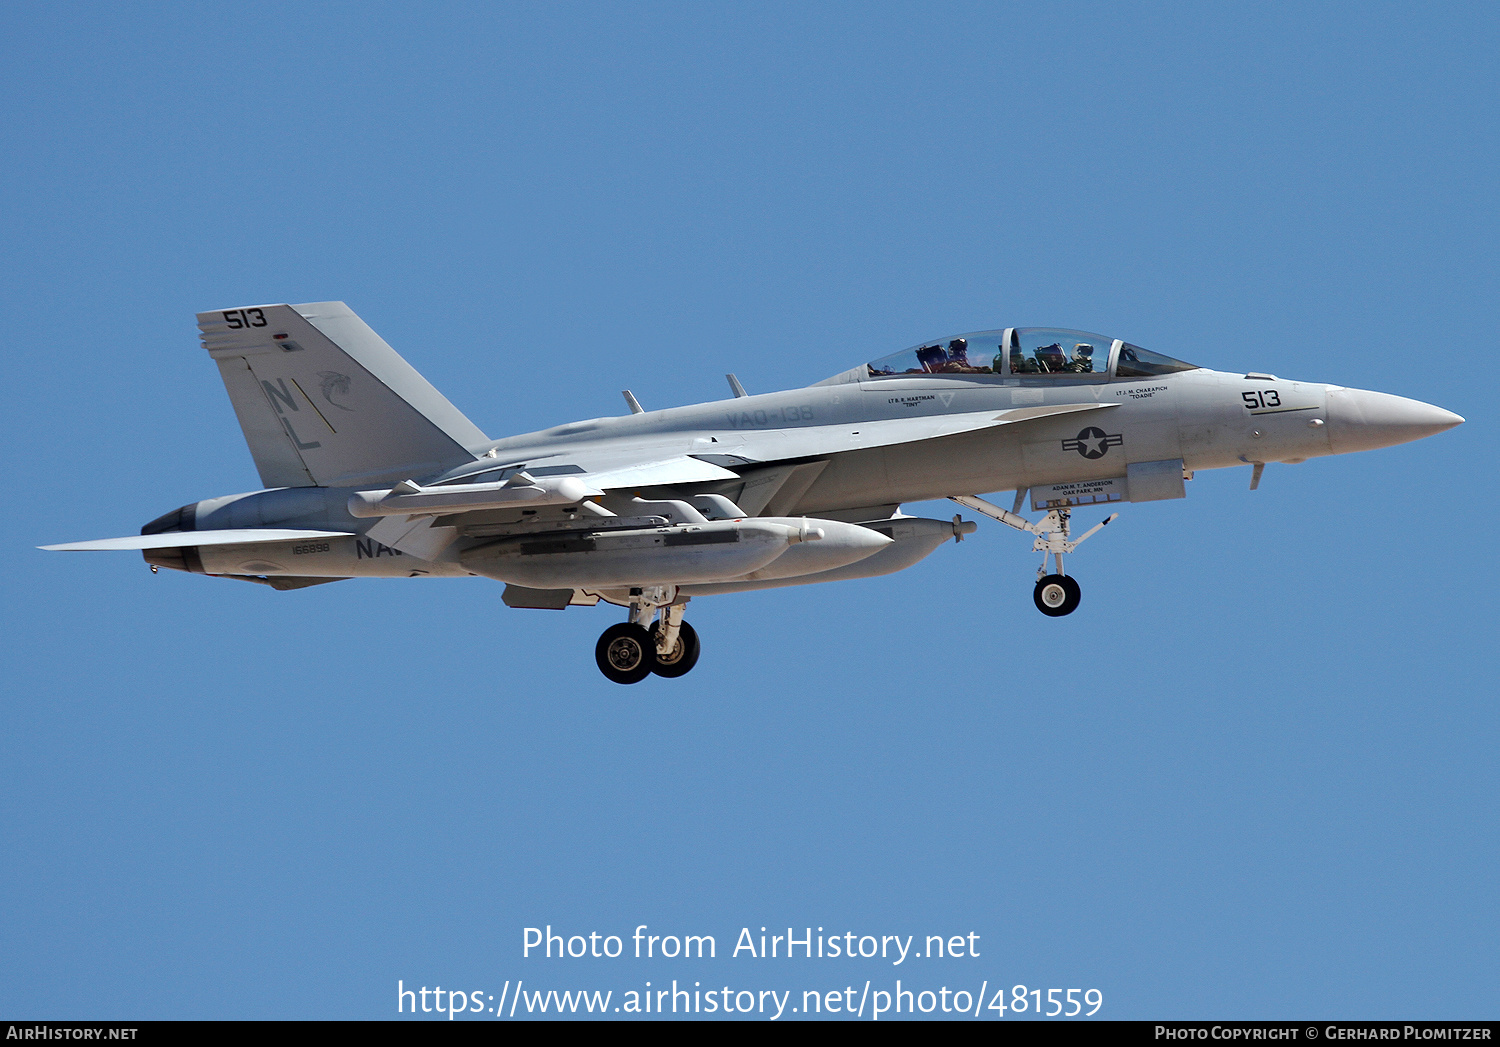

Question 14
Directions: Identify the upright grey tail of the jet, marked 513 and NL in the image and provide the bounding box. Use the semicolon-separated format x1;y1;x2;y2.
198;302;489;488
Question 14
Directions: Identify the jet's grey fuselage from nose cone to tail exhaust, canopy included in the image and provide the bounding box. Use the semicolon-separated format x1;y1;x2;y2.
132;329;1463;576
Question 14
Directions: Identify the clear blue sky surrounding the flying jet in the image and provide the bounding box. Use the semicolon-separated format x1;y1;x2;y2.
0;3;1500;1019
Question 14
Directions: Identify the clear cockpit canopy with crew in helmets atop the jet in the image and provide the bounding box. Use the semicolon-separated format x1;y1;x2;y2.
866;327;1197;378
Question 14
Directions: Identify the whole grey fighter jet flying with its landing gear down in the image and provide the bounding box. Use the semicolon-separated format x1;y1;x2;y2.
44;302;1463;684
